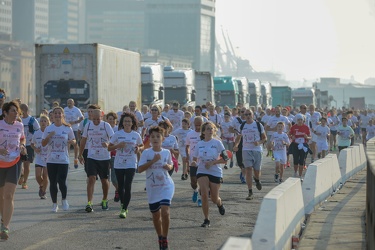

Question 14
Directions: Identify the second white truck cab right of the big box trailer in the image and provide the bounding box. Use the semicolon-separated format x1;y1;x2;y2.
164;66;196;107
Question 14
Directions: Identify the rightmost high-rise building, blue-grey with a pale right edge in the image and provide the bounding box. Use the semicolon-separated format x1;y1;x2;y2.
145;0;215;74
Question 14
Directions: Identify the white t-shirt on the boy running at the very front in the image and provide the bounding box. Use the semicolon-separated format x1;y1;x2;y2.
139;148;174;204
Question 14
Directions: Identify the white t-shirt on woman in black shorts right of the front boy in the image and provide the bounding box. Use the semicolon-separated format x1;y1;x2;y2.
193;139;225;178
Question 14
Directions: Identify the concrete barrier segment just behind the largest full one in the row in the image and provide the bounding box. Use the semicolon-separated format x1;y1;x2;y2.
302;154;341;214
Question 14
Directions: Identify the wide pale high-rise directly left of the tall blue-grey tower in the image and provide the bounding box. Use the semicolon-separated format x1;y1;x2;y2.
85;0;145;49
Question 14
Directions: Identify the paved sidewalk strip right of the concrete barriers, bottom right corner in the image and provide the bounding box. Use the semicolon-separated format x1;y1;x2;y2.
298;168;366;250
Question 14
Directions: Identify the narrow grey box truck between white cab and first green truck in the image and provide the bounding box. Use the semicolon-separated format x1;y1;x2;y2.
195;71;215;105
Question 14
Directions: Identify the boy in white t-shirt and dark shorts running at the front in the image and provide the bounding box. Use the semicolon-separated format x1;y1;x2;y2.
138;126;174;249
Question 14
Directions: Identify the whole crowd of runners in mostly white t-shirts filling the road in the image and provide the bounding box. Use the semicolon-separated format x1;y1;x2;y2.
0;86;375;249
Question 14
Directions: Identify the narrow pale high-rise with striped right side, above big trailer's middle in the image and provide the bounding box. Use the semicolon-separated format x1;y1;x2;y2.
48;0;80;43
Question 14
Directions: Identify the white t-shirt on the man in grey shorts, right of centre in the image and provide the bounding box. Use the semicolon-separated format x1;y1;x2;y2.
240;121;264;152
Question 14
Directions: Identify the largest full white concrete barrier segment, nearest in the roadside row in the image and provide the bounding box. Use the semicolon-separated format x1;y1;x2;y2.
251;178;305;250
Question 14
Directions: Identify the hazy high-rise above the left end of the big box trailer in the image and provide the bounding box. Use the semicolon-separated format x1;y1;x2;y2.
12;0;49;43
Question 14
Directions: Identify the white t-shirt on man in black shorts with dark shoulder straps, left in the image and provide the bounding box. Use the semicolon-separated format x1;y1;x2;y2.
82;121;113;161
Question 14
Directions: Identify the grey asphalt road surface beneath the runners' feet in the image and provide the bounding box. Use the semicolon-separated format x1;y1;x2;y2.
0;150;318;250
